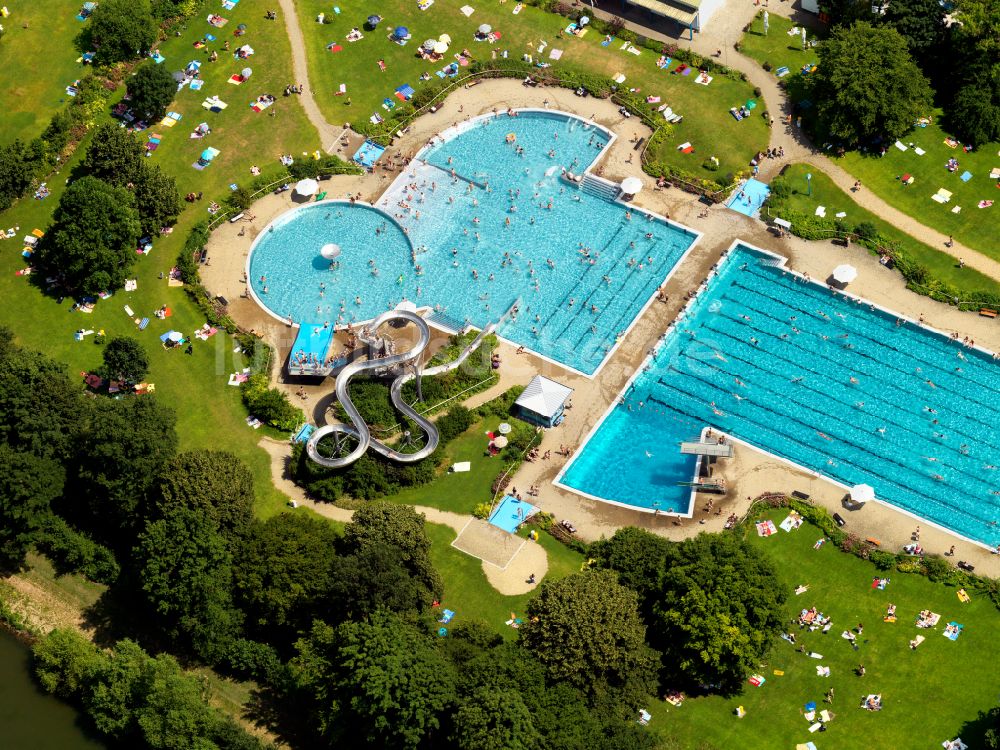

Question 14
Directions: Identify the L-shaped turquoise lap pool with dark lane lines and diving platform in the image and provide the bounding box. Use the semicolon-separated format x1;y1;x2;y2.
560;246;1000;545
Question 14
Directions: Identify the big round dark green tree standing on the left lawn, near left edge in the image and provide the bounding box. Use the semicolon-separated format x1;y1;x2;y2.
35;177;140;295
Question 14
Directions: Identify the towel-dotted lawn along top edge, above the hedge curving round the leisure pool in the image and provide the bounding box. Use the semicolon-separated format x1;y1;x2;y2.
297;0;768;177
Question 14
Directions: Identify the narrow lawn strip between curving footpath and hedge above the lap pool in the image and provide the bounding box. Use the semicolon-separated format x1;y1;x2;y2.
772;164;1000;294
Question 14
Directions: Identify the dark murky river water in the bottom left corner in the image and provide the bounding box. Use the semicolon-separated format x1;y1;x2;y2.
0;628;104;750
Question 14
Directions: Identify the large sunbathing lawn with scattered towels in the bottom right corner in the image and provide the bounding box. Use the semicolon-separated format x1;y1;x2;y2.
647;511;1000;750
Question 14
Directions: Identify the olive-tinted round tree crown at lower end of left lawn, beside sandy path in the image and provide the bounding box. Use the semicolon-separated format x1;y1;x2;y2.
153;451;256;540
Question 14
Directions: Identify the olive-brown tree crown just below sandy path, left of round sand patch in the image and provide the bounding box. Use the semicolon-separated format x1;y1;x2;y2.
343;502;443;596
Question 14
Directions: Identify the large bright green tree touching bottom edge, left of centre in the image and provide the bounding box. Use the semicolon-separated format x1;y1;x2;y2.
290;612;455;748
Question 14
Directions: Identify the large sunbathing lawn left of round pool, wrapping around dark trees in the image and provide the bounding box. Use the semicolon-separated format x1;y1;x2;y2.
0;0;319;516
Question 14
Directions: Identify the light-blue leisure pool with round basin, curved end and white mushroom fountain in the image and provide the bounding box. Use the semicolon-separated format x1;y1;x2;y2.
249;111;697;374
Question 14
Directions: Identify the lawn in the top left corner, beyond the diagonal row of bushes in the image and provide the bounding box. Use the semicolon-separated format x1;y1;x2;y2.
0;0;86;146
